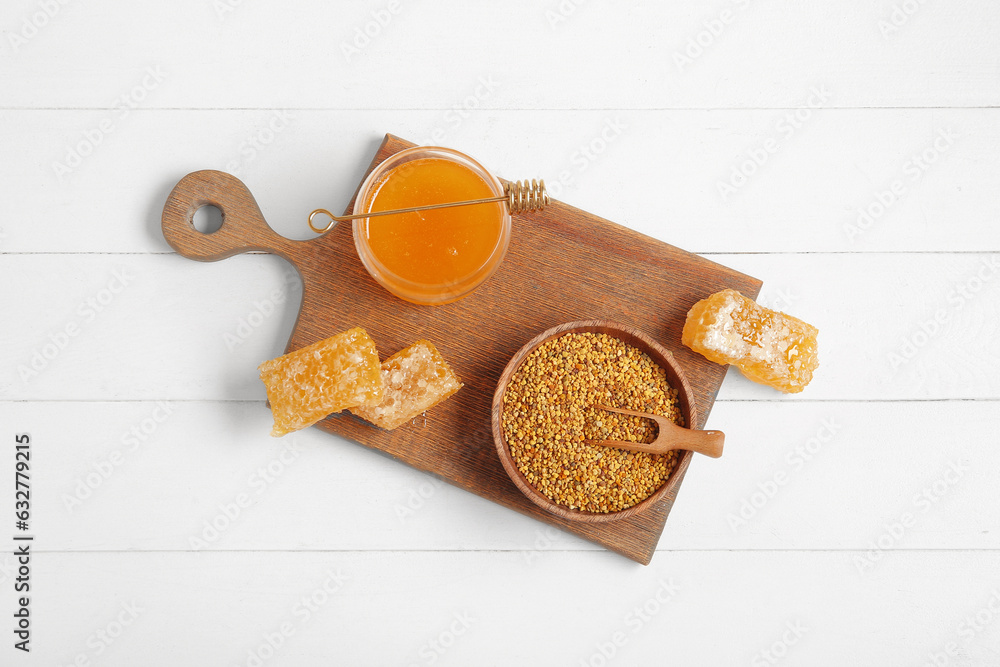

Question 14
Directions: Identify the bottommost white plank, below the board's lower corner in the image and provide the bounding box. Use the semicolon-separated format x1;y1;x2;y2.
0;551;1000;665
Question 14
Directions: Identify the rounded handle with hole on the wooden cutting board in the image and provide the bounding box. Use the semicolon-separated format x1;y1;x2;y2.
162;169;302;262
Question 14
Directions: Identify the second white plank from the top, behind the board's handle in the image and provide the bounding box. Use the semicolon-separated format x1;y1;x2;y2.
0;111;1000;252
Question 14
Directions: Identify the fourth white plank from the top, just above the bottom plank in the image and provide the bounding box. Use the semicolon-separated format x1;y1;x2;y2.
0;401;1000;551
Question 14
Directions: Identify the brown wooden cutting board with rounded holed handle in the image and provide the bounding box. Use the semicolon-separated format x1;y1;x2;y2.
163;135;761;565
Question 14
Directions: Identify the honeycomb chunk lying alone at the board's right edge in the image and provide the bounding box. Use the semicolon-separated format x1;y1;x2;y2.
681;289;819;393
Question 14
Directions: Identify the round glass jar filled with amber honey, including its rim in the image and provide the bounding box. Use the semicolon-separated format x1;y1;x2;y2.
354;147;510;304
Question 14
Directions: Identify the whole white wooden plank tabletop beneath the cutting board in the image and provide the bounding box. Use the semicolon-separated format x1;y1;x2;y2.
0;0;1000;667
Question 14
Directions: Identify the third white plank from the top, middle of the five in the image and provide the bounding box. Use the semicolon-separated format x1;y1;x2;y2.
0;253;1000;401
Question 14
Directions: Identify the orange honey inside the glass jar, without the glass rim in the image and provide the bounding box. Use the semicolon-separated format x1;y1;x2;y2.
363;158;504;293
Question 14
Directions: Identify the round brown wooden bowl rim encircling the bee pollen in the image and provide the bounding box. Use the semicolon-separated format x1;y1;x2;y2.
493;320;698;523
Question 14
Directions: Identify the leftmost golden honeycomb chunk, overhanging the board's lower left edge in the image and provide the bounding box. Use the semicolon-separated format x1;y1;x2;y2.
258;327;383;436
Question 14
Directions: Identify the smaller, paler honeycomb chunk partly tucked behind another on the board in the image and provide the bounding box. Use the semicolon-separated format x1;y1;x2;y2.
351;340;462;431
